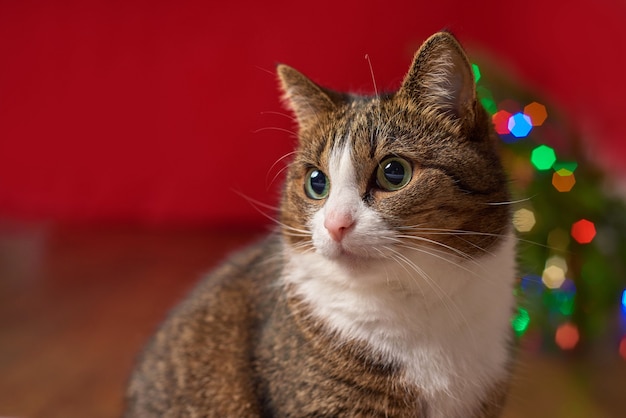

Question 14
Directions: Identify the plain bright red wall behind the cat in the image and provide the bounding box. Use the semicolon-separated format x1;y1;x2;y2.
0;0;626;225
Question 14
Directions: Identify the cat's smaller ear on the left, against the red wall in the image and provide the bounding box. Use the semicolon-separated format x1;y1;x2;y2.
276;64;342;127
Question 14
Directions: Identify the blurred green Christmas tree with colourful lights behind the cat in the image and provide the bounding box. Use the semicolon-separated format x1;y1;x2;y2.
473;63;626;359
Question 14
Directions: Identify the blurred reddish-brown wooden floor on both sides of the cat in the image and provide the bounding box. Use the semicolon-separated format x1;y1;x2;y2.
0;224;626;418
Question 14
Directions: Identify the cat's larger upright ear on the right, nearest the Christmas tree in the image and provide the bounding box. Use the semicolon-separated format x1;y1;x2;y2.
398;32;476;119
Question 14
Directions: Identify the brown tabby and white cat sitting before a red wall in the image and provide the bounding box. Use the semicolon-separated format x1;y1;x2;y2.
126;32;515;418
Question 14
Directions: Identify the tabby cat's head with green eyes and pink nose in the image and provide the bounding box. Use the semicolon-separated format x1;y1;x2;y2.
278;32;509;268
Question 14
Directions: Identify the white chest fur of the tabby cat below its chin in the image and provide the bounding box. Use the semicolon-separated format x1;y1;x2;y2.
285;234;515;418
